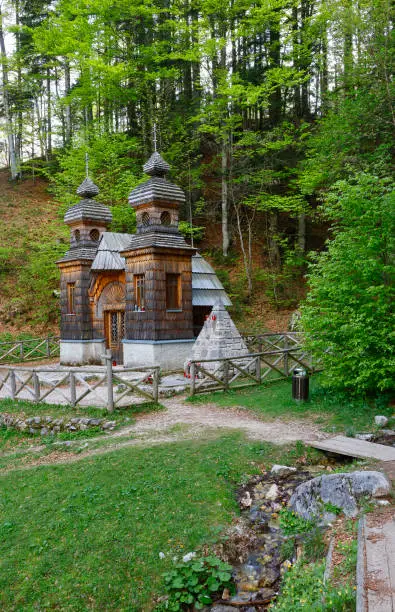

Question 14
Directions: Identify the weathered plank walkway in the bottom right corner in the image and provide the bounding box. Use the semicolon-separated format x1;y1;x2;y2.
356;510;395;612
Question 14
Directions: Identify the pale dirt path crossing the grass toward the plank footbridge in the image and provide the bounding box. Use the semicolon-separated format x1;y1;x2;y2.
1;397;327;474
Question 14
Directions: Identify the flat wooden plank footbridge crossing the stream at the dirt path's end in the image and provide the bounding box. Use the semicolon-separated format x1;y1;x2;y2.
306;436;395;461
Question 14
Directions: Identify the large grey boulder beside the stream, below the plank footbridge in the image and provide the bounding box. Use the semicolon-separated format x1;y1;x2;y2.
290;471;390;520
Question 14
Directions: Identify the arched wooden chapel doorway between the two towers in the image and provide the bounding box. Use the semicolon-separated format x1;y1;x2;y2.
97;281;125;363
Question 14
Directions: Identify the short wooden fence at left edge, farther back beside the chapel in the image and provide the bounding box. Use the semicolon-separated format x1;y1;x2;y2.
0;336;60;363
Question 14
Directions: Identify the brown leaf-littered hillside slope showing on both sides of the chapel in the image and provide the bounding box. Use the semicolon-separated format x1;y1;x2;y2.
0;170;303;337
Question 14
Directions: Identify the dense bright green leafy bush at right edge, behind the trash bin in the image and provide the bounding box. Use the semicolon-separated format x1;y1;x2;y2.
302;174;395;394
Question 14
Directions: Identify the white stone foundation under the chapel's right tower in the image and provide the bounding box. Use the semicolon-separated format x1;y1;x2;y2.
122;339;195;372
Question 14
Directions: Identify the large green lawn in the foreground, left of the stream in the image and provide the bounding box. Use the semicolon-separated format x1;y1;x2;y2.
0;434;296;612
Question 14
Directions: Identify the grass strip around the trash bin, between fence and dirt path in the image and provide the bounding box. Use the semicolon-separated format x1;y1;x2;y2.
190;376;393;435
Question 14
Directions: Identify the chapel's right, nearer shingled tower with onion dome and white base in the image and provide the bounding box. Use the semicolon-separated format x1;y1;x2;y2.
122;151;195;369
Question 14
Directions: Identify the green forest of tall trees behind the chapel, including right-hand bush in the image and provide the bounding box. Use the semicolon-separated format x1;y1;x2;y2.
0;0;395;392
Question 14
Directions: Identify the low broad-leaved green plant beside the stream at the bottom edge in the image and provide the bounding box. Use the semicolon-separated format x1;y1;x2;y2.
164;556;234;612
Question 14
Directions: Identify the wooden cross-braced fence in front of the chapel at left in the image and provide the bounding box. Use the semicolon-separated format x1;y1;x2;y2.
0;353;160;412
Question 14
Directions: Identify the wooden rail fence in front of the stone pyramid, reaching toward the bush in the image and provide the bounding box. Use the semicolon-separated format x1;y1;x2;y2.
189;345;317;396
